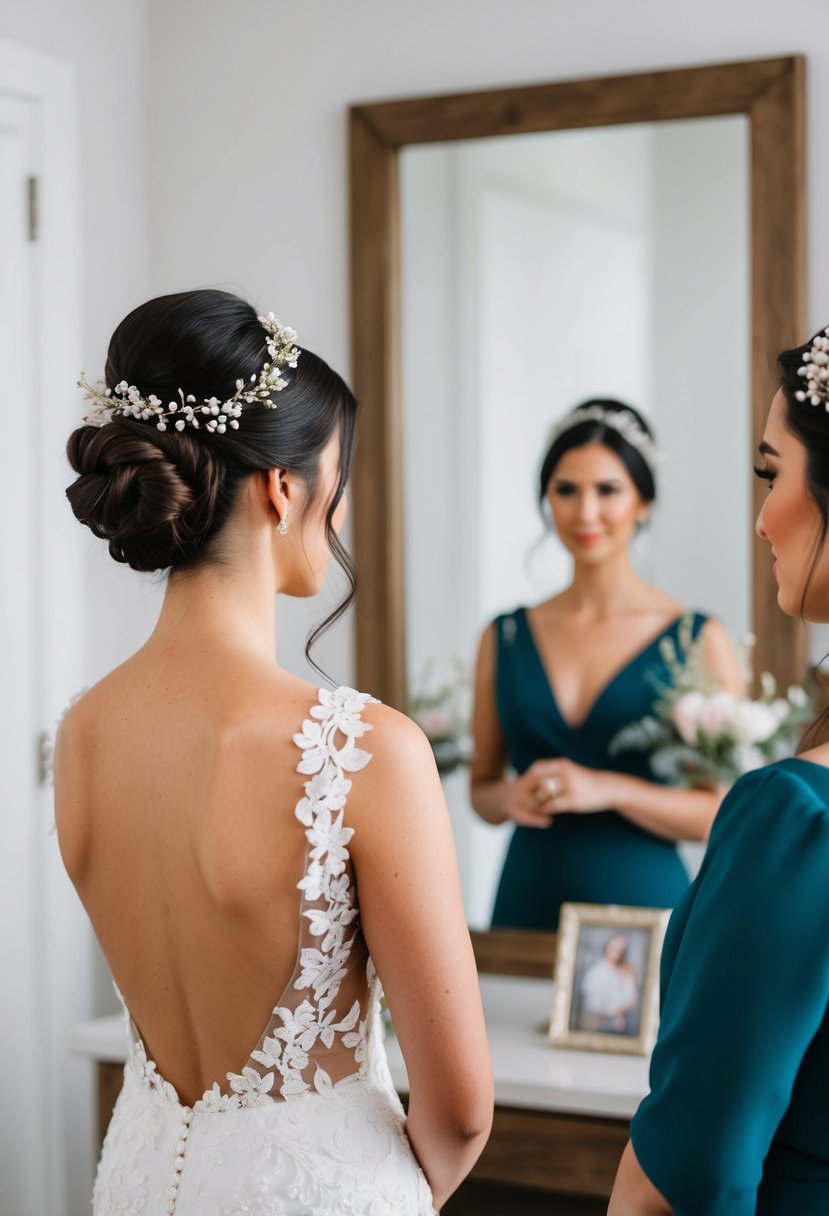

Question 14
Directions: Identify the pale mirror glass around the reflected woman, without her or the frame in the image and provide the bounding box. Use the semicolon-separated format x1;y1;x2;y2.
401;116;752;928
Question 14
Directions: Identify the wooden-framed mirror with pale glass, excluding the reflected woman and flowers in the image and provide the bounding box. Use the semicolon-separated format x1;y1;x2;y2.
351;58;806;963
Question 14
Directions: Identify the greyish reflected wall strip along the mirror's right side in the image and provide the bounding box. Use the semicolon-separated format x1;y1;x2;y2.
649;116;748;637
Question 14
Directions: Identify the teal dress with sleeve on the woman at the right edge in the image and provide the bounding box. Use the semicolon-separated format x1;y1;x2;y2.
631;760;829;1216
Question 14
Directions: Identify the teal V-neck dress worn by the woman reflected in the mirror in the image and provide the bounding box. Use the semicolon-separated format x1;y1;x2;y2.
492;608;707;930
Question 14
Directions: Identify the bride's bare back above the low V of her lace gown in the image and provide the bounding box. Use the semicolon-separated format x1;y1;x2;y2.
56;646;316;1100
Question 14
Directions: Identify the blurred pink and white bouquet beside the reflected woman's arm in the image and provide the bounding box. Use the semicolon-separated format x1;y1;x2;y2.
610;618;813;786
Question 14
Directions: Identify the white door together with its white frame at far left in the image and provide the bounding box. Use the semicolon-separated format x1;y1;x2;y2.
0;43;92;1216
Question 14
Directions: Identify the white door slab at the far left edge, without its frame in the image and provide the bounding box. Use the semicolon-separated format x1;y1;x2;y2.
0;83;47;1216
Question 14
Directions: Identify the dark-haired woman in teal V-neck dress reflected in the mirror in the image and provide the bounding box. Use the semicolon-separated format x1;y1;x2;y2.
470;400;743;930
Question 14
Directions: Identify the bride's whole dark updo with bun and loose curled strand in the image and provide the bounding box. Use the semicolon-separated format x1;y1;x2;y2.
67;291;357;654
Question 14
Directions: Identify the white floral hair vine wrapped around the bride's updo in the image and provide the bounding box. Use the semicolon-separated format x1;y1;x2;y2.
78;313;301;435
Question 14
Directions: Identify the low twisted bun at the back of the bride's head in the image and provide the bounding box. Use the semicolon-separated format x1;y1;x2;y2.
67;418;224;572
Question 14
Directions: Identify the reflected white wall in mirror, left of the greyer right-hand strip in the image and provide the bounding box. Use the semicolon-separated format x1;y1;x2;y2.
400;128;652;700
